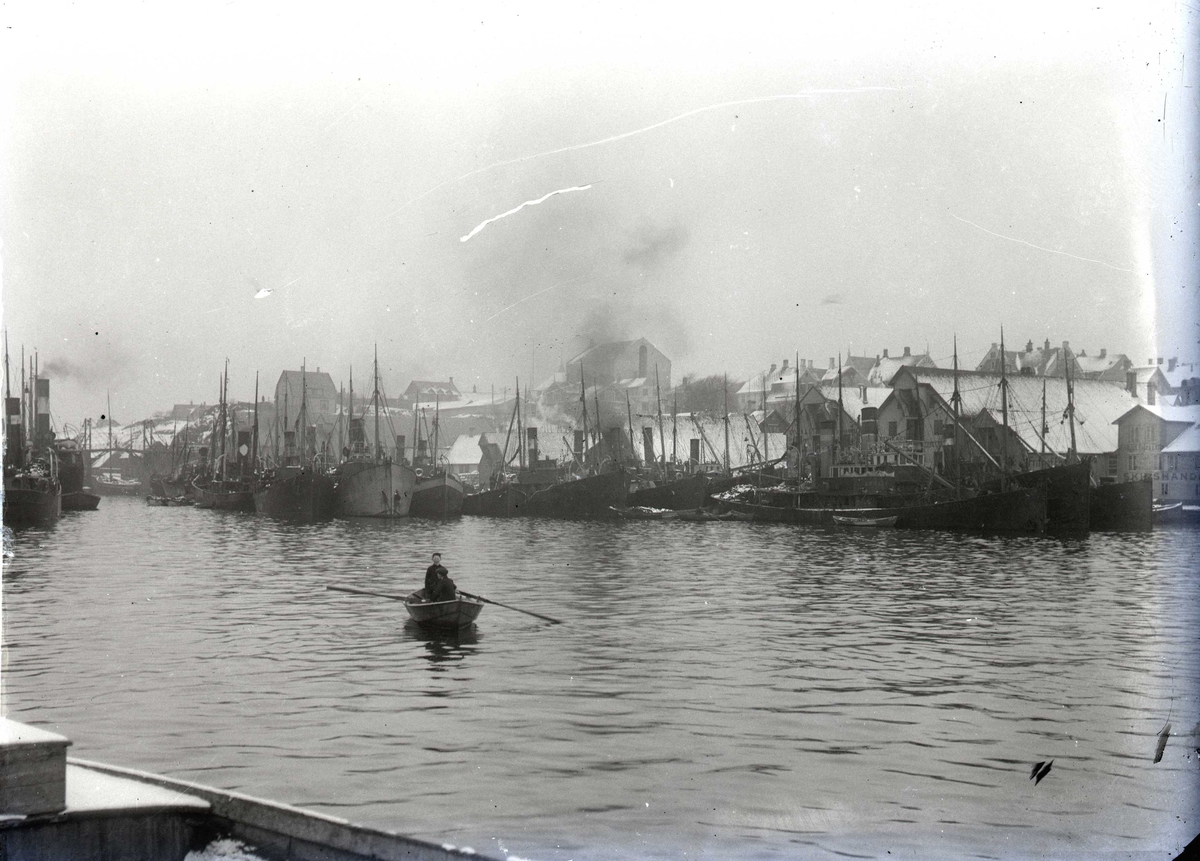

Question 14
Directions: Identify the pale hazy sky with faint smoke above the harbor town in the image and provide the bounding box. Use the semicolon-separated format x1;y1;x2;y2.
0;0;1200;427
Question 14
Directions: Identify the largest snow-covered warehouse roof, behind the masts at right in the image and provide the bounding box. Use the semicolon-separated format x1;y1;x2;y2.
902;368;1139;454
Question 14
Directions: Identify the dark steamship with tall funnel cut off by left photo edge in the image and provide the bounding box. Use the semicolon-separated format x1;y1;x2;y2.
4;347;62;528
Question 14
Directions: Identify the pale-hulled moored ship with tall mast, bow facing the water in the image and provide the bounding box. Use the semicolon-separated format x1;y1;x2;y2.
334;354;416;517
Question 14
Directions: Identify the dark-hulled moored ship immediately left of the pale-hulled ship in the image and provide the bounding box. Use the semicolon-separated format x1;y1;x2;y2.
252;363;335;523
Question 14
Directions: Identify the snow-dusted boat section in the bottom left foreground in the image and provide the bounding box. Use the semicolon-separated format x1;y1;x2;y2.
0;718;490;861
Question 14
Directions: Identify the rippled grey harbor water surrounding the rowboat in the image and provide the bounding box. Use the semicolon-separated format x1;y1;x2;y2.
0;498;1200;861
